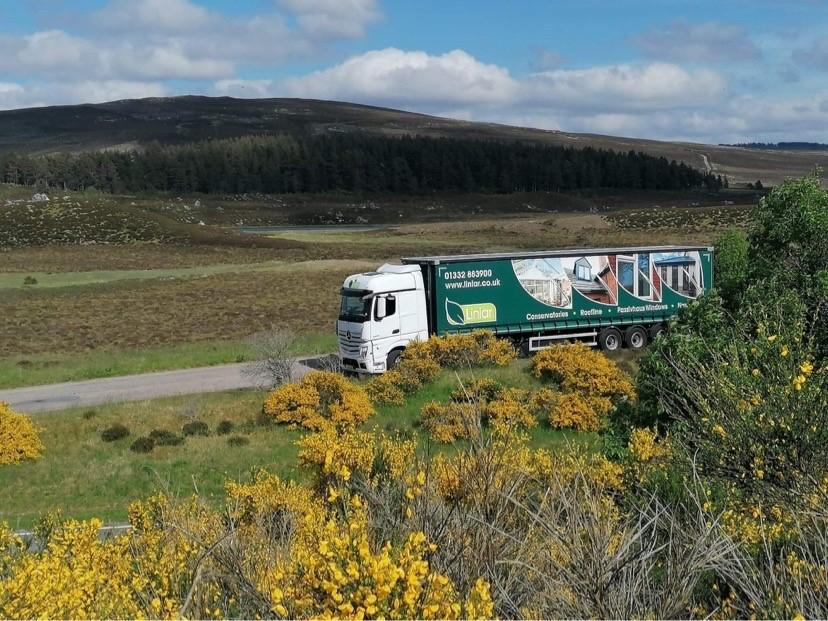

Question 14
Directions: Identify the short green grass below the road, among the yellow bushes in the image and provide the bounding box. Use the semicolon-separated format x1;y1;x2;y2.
0;360;597;528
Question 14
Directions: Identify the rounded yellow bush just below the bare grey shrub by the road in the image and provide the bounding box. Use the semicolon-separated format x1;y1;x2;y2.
263;371;374;431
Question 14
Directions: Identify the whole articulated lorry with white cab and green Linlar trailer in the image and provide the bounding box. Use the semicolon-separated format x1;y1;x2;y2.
337;246;713;373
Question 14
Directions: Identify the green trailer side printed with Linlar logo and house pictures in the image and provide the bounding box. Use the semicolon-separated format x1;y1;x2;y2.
403;246;713;335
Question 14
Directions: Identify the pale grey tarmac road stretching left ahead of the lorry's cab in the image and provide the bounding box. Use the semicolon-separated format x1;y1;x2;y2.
0;359;314;413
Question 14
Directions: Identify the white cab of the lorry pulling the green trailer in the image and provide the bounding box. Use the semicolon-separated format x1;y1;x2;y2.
336;263;428;374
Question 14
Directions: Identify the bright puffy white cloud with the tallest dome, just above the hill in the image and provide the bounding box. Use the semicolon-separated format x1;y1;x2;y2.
279;48;519;105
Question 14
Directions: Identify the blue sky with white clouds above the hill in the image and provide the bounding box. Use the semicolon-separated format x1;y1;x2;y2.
0;0;828;143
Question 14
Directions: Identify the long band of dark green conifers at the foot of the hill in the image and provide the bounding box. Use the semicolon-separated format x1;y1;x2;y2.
0;134;726;193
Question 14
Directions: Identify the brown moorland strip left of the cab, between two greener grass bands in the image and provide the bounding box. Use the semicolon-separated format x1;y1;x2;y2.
0;262;365;355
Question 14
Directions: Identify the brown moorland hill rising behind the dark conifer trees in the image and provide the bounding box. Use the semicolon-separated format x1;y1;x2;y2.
0;96;828;185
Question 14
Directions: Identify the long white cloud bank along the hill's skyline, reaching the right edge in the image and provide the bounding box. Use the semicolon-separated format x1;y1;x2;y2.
258;48;828;143
